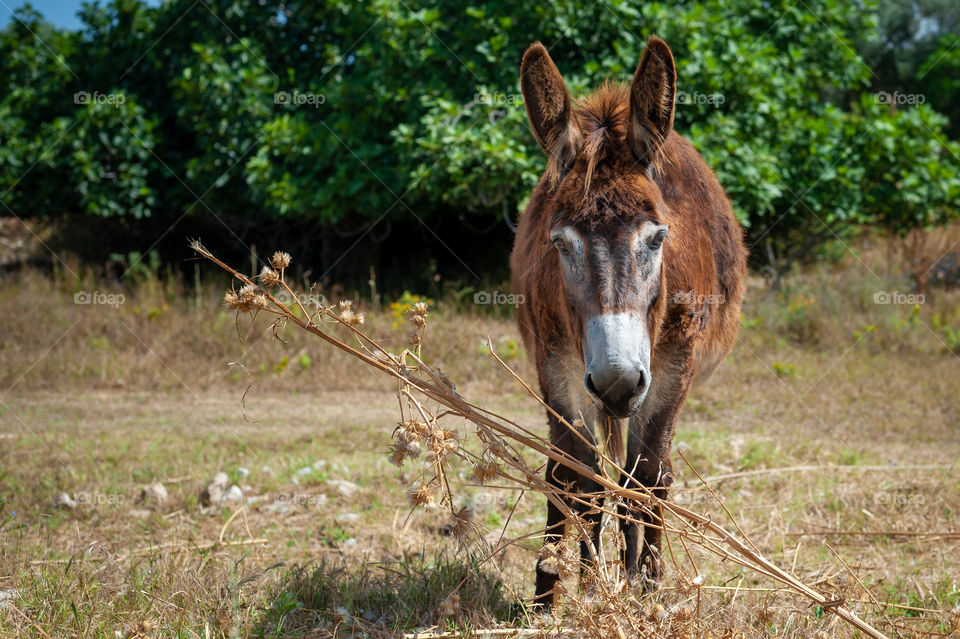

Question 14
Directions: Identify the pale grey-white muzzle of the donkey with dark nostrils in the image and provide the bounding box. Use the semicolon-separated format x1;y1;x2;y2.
583;313;650;417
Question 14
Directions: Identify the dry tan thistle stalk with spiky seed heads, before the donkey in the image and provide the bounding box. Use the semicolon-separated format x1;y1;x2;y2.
191;241;885;639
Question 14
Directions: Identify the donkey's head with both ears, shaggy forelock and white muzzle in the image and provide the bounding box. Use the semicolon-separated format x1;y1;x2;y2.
521;36;676;417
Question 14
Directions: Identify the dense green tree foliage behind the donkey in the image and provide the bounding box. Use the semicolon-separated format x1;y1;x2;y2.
0;0;960;282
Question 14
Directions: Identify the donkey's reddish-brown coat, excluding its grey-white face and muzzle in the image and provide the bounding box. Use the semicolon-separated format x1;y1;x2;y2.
511;37;746;604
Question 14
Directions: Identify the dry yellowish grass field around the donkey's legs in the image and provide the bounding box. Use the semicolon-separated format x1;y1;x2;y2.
0;246;960;637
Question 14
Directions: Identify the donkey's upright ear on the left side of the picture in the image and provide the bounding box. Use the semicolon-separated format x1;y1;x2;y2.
520;42;583;180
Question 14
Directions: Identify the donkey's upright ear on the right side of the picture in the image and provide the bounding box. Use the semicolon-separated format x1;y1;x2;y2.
627;36;677;164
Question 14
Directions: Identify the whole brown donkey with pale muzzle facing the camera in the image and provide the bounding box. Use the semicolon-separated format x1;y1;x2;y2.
510;36;746;605
